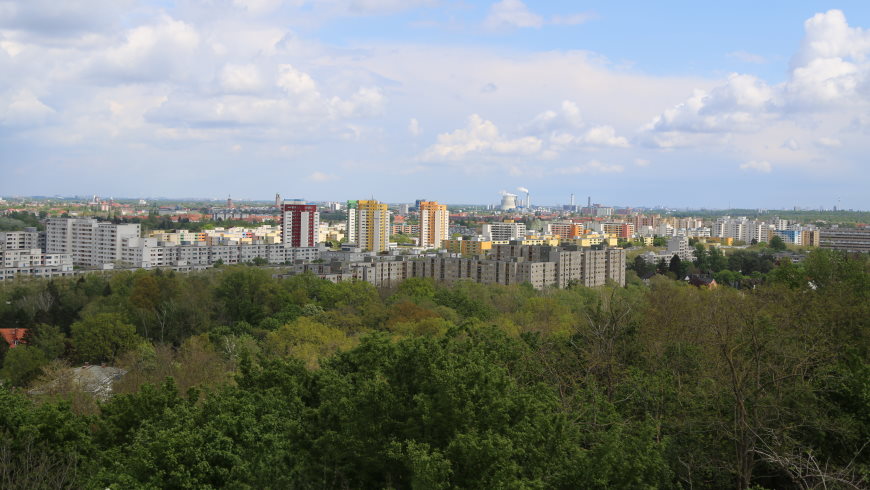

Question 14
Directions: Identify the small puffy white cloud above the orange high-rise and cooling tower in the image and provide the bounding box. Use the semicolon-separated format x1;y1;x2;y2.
422;114;543;161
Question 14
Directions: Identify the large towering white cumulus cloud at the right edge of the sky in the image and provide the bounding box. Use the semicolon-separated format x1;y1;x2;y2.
638;10;870;161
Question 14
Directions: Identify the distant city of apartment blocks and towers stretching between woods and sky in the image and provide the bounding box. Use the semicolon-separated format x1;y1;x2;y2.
0;193;870;289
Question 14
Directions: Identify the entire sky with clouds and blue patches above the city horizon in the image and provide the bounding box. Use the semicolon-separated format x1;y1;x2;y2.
0;0;870;210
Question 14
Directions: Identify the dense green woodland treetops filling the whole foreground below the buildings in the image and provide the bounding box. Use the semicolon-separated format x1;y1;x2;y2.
0;256;870;489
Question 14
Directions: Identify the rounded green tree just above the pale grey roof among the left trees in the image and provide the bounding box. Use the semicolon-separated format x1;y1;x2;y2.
72;313;142;362
